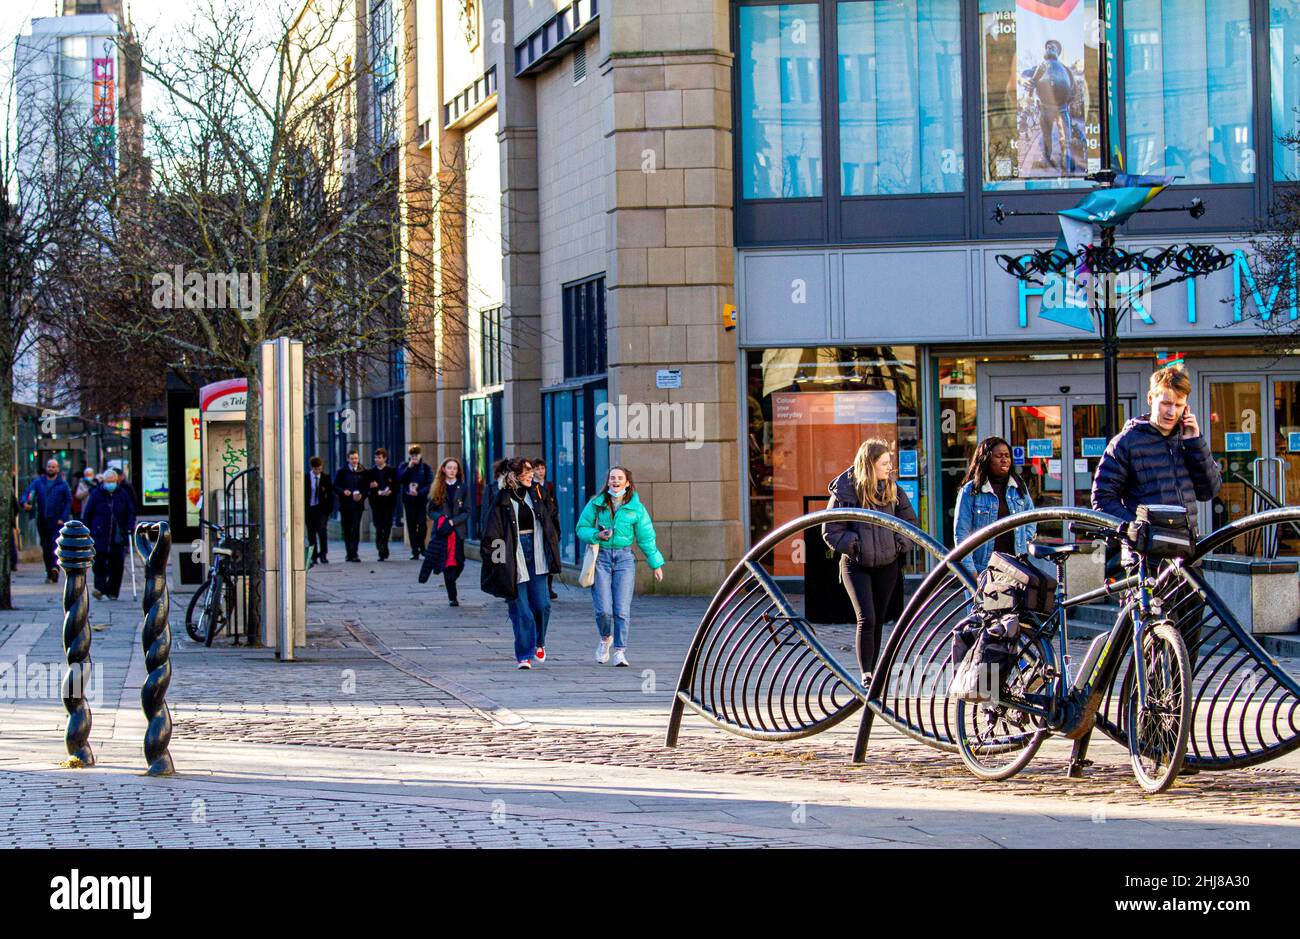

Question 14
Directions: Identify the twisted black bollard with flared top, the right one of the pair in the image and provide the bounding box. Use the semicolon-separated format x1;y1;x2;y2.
134;522;176;776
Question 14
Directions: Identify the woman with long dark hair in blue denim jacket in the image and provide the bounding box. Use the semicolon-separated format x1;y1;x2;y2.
953;437;1037;576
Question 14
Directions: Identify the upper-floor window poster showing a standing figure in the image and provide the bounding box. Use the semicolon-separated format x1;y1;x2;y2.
982;0;1101;182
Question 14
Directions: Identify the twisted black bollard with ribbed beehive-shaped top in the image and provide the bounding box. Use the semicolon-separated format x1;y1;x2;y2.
55;519;95;766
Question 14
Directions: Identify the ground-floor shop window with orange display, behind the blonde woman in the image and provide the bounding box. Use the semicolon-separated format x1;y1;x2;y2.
748;346;928;577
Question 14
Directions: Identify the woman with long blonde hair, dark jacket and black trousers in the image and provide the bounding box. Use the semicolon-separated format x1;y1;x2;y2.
822;437;917;684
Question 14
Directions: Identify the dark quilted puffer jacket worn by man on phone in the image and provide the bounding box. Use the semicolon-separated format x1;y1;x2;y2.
1092;414;1223;527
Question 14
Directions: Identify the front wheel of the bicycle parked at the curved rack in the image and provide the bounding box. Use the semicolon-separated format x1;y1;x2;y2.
1125;622;1192;792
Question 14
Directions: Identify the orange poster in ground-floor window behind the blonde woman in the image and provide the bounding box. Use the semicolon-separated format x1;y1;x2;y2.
772;391;898;576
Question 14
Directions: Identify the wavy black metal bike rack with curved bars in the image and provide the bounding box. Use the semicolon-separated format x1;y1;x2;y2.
667;507;1300;770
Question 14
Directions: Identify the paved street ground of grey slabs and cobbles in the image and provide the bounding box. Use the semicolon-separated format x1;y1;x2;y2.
0;533;1300;847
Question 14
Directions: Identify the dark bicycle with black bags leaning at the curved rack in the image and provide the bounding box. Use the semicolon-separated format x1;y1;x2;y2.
954;529;1192;792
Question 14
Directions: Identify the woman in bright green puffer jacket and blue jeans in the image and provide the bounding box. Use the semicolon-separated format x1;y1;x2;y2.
577;467;663;667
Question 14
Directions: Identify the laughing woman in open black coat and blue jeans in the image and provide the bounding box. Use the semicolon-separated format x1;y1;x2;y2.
480;459;560;668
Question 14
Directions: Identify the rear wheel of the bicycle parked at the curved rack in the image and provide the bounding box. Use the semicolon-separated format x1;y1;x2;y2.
957;632;1052;780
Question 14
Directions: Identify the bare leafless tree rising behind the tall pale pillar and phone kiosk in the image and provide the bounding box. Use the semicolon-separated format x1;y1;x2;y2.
61;0;464;621
